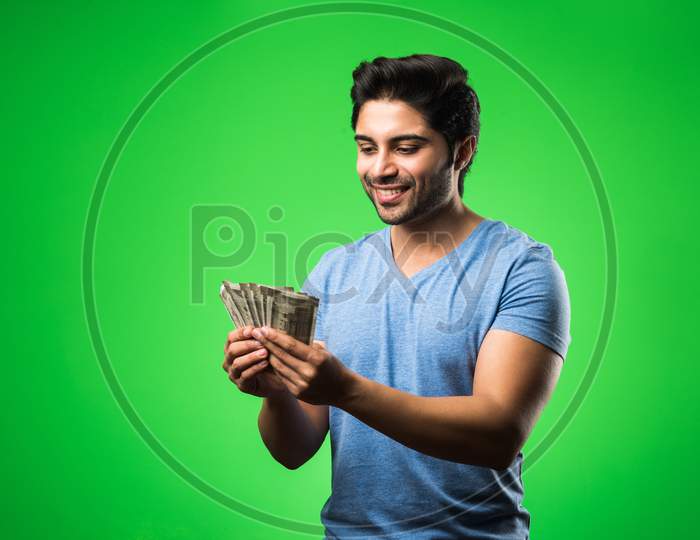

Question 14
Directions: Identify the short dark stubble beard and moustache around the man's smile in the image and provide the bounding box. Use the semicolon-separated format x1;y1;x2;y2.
363;157;453;225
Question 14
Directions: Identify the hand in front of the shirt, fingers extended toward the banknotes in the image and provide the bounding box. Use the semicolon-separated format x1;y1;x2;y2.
253;326;355;406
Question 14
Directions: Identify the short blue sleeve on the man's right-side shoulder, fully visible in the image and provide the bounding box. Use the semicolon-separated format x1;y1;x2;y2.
491;244;571;359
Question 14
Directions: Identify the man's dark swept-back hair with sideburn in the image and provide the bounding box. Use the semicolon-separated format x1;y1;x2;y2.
350;54;481;197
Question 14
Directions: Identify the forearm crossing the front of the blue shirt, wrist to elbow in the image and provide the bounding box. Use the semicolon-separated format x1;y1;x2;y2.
337;373;517;469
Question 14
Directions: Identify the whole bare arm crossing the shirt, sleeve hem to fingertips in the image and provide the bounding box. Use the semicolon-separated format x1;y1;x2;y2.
254;328;563;469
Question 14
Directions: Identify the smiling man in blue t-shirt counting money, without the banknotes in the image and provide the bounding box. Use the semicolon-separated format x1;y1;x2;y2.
223;55;571;539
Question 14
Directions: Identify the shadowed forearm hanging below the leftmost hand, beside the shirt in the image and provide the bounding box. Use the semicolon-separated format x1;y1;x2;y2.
258;392;319;469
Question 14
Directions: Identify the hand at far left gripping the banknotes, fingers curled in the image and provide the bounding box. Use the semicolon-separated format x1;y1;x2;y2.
222;326;288;397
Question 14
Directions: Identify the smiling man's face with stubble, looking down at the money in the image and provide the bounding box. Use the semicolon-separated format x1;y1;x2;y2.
355;100;458;225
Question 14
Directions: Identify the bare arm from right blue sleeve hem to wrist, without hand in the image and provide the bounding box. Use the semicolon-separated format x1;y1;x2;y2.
339;330;563;469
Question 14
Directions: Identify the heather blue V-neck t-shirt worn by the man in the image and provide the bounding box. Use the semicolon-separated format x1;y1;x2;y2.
302;219;571;540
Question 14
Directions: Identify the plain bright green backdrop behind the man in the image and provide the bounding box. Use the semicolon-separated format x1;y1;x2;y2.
0;1;699;539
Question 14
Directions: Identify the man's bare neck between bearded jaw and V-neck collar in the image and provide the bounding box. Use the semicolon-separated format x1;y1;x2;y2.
390;197;484;255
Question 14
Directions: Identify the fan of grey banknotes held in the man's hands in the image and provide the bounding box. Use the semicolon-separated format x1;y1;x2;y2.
219;280;318;345
